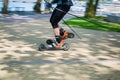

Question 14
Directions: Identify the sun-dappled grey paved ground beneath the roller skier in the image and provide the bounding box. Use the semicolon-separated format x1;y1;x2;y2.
0;14;120;80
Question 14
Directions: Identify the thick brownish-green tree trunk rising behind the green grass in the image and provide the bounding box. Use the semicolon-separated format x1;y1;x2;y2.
85;0;99;18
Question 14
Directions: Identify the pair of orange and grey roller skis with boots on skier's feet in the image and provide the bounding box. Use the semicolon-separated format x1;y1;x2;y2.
38;29;74;51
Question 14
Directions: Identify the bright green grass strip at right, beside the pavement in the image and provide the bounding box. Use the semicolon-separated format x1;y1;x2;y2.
66;16;120;32
